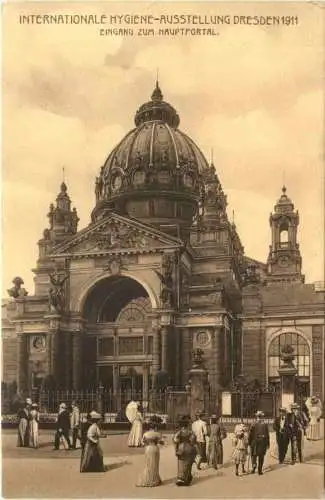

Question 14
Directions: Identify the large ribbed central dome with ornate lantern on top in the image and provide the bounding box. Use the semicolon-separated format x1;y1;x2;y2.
93;83;208;234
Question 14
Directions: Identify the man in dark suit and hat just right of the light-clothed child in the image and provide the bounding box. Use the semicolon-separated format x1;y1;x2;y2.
248;411;270;476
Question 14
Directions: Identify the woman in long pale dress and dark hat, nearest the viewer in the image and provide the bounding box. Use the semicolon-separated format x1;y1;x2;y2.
137;415;164;488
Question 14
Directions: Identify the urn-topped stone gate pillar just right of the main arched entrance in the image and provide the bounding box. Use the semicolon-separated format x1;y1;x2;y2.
190;349;209;420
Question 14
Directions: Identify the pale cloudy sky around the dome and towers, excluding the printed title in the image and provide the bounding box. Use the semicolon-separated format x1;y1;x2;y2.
2;2;325;293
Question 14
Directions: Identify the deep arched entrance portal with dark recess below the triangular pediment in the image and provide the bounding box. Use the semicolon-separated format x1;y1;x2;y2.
83;276;153;403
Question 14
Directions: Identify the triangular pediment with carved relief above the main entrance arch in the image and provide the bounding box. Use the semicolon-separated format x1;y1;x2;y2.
51;213;182;256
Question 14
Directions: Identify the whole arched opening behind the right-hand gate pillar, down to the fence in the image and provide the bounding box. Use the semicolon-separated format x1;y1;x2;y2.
267;332;311;400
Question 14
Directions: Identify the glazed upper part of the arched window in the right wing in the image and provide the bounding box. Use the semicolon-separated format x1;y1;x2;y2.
268;333;310;378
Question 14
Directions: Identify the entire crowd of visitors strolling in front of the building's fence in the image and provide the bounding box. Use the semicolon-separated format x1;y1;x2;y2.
18;398;320;487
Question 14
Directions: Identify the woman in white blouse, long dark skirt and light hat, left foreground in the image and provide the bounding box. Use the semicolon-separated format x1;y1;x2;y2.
80;411;105;472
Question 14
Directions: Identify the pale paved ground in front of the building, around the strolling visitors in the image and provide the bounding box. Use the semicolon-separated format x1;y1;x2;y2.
2;431;324;499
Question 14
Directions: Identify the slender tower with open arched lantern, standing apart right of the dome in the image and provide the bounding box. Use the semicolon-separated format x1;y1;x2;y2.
267;186;304;282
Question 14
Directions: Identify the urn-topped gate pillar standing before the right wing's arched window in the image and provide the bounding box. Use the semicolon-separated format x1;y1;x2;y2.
278;346;297;408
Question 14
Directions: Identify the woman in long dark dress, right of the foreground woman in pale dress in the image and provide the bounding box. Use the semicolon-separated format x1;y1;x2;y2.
173;415;196;486
